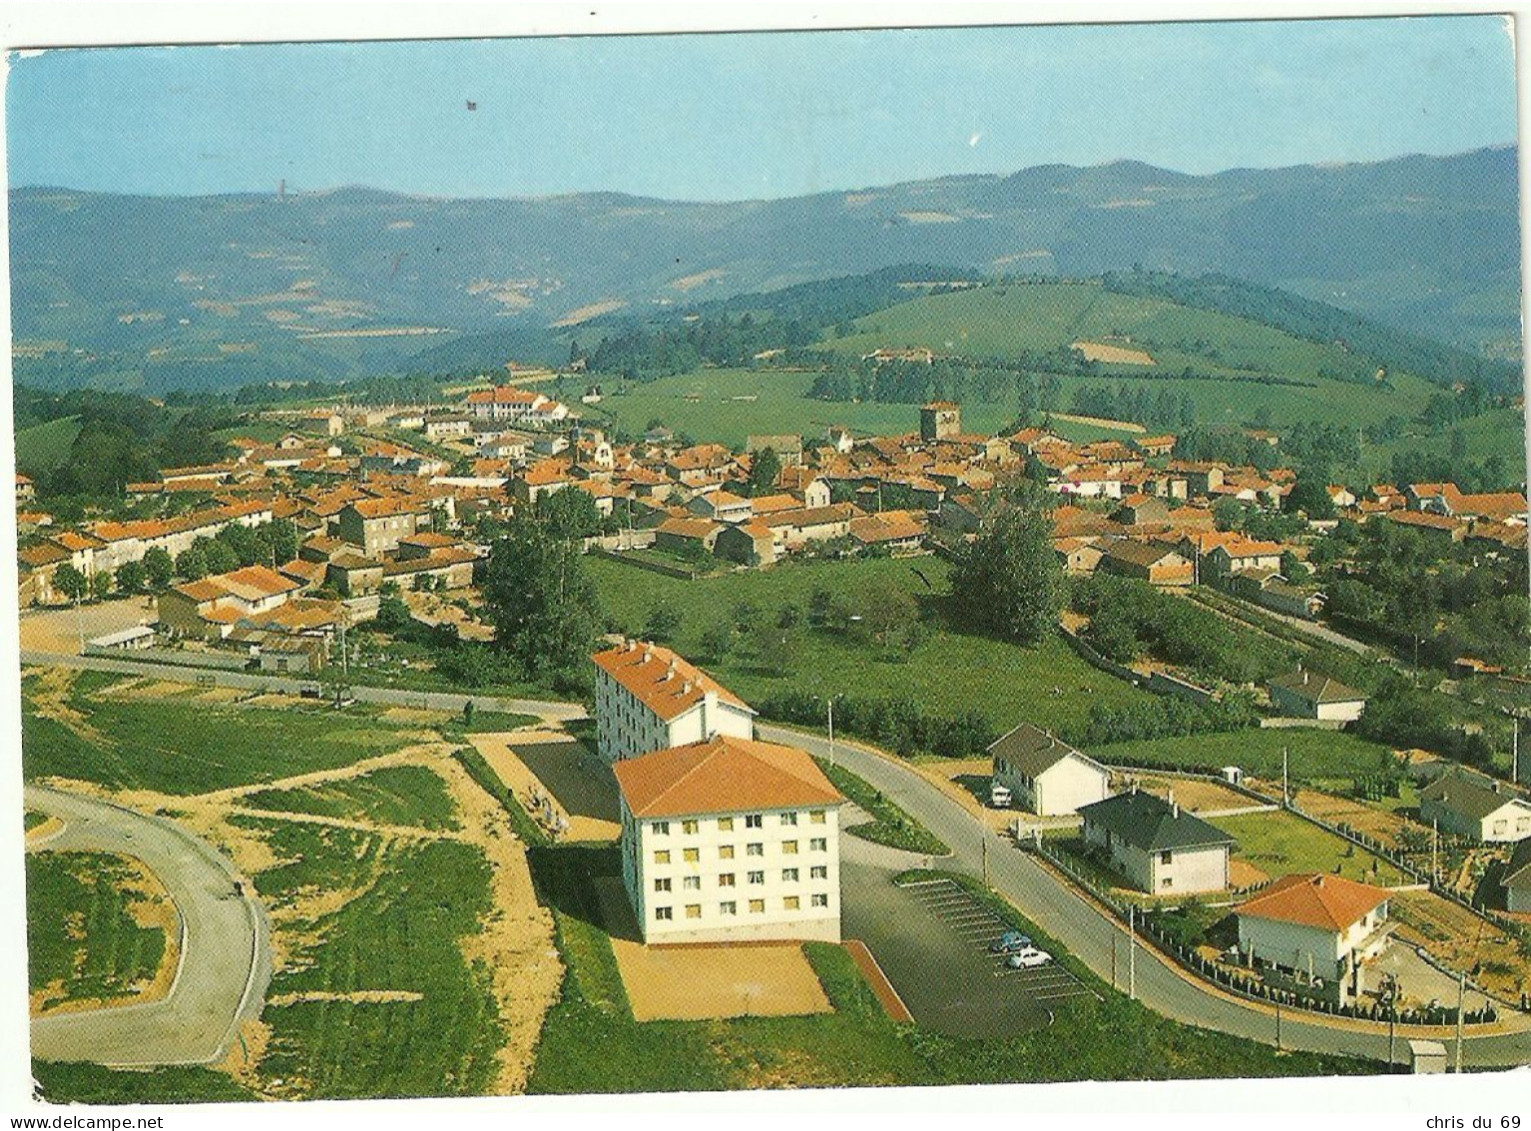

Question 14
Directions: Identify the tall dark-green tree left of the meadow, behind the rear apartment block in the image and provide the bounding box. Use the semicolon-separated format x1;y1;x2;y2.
484;520;600;676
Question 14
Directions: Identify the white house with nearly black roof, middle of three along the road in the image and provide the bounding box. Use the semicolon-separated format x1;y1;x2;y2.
1079;787;1236;895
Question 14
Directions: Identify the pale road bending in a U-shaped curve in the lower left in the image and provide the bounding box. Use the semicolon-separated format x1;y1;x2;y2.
24;785;271;1068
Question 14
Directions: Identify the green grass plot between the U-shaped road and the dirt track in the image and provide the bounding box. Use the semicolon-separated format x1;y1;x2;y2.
240;819;502;1099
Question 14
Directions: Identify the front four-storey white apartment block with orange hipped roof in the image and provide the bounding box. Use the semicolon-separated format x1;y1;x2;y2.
612;735;845;946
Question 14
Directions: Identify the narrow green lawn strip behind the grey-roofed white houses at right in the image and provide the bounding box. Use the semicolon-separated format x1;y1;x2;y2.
1089;727;1387;781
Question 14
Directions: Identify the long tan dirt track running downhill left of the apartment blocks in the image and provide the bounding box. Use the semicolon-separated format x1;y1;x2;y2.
432;759;563;1096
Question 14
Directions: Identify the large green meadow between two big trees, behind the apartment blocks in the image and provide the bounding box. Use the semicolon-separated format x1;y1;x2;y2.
585;557;1148;743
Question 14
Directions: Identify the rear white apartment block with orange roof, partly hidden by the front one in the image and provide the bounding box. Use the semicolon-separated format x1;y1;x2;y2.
591;640;755;762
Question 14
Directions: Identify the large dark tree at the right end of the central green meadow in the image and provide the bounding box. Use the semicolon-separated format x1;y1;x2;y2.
952;510;1063;643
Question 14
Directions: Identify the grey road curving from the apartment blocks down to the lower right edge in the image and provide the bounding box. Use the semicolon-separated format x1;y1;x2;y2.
759;725;1531;1068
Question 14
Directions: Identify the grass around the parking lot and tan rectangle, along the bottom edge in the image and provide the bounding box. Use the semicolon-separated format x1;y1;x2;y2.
528;848;1372;1093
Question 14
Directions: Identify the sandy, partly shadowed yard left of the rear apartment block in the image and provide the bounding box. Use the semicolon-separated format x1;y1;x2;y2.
468;728;622;840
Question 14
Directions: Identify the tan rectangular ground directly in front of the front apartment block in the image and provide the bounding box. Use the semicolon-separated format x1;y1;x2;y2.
596;877;831;1021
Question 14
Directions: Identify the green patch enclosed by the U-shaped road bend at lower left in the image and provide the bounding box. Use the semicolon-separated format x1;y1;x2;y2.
26;852;165;1009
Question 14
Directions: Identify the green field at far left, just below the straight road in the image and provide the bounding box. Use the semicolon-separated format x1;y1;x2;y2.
21;673;419;794
